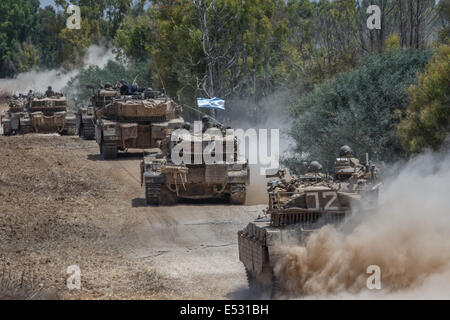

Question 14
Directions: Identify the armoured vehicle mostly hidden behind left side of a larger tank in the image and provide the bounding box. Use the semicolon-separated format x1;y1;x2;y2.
77;85;120;140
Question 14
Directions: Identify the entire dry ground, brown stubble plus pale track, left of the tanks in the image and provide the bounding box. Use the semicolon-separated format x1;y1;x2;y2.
0;135;264;299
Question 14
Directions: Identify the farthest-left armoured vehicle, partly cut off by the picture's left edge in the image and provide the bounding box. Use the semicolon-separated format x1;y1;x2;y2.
1;94;32;136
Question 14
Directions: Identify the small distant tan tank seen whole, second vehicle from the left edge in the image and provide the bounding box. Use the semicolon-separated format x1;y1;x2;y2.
25;93;76;135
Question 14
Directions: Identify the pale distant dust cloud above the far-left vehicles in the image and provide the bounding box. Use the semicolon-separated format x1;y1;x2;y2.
0;45;115;95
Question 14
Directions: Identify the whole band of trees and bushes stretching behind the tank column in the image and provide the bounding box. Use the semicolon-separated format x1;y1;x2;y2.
0;0;450;163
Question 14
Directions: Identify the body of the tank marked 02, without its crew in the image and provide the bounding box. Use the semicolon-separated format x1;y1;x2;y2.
238;182;370;298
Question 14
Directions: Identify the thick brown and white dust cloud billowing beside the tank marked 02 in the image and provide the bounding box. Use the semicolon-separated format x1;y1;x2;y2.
275;152;450;299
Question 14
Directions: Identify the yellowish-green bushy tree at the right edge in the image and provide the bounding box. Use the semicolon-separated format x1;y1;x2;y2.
398;45;450;153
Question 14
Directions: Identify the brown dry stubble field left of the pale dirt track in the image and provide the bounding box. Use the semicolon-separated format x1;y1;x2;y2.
0;135;169;299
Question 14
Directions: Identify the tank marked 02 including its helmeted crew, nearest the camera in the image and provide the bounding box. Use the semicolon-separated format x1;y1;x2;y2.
238;147;380;298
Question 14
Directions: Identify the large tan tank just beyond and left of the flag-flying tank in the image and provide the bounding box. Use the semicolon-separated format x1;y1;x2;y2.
95;90;184;159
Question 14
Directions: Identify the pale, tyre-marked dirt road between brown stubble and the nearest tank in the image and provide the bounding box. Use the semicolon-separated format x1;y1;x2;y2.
93;151;263;299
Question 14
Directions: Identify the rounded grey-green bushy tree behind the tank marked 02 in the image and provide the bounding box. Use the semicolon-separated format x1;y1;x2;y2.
290;50;431;169
